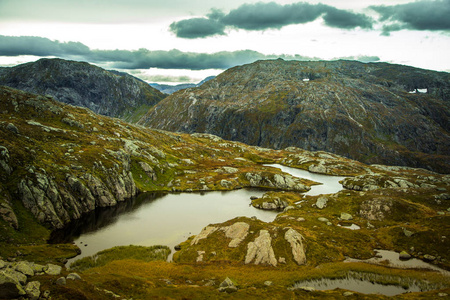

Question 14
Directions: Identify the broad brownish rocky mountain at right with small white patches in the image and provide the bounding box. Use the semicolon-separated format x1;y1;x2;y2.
139;59;450;173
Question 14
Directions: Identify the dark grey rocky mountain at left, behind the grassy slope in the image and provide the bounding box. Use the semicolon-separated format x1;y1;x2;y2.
0;59;166;121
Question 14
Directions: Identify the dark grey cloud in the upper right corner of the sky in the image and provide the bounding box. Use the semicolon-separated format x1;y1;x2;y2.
370;0;450;33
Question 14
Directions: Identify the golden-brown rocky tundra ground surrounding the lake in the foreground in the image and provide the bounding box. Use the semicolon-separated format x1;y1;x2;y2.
0;87;450;299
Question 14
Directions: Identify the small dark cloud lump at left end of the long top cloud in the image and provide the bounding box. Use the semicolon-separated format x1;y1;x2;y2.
170;18;225;39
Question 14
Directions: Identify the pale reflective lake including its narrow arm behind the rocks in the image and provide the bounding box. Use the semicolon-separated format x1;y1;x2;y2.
51;165;343;265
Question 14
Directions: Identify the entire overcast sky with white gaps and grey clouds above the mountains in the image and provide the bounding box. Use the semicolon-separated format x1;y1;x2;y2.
0;0;450;83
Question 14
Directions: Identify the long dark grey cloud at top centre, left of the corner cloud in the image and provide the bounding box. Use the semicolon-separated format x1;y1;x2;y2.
170;2;373;38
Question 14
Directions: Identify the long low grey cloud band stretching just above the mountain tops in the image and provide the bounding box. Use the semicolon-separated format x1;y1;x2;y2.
0;35;379;70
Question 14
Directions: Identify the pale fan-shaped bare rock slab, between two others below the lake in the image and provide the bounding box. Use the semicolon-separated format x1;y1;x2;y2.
245;230;278;267
